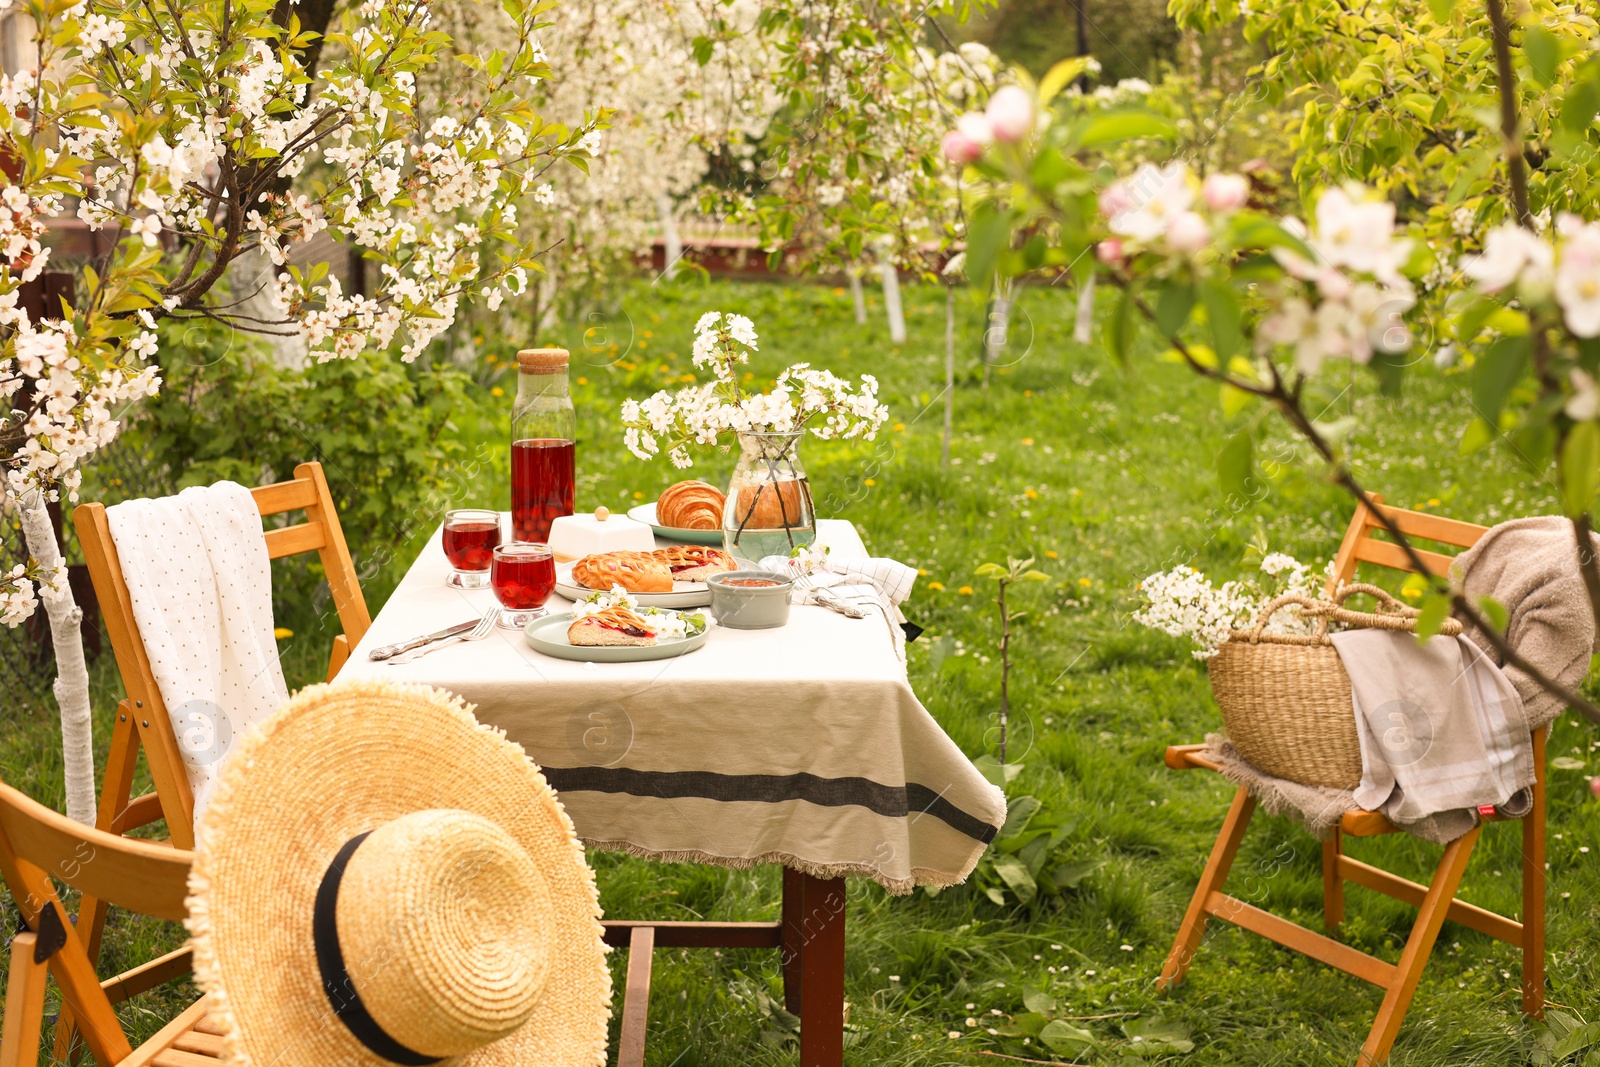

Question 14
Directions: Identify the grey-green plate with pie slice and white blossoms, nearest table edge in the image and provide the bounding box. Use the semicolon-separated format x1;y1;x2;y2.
523;589;712;664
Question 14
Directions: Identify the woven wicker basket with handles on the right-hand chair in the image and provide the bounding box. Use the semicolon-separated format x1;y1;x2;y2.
1211;582;1461;789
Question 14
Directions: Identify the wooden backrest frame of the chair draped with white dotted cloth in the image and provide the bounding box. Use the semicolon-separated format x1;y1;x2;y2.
72;462;373;848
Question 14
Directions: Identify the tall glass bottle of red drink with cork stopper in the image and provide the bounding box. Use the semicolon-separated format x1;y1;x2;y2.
510;349;578;541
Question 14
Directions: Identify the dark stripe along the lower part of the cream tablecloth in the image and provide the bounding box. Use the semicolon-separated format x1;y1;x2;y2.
542;766;998;845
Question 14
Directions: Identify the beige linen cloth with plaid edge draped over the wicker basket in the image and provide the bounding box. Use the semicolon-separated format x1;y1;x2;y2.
1333;630;1534;841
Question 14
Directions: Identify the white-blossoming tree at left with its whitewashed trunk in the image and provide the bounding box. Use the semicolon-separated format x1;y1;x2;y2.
0;0;605;822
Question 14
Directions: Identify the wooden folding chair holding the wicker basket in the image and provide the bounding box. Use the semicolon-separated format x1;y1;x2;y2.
1158;498;1546;1067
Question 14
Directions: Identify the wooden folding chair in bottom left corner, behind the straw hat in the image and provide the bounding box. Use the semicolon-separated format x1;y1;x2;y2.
0;784;222;1067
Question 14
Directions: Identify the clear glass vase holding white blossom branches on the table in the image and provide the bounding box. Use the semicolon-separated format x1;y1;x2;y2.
722;430;816;563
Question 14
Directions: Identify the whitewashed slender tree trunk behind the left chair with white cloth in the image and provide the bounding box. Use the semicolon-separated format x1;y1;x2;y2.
21;493;94;825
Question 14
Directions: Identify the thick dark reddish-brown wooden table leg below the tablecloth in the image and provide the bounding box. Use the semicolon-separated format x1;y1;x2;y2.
782;867;845;1067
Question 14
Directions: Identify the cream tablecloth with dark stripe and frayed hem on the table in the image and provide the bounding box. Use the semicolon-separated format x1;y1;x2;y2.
339;520;1005;893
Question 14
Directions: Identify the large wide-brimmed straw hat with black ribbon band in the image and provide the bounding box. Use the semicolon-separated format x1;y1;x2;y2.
189;681;611;1067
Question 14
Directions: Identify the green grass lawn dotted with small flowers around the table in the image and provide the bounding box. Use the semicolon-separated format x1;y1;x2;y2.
0;282;1600;1067
